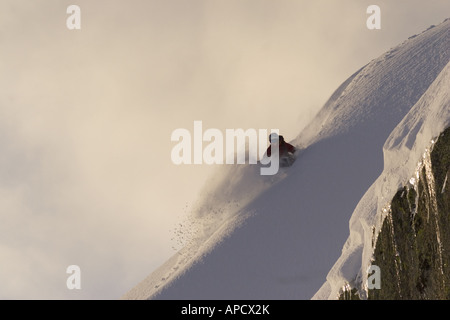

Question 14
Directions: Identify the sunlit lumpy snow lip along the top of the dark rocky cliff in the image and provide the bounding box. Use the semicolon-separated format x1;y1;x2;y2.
314;58;450;299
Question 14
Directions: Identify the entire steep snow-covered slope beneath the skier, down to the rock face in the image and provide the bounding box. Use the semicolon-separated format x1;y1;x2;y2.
122;20;450;299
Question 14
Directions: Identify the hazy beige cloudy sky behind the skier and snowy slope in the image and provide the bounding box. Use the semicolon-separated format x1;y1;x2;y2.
0;0;450;299
